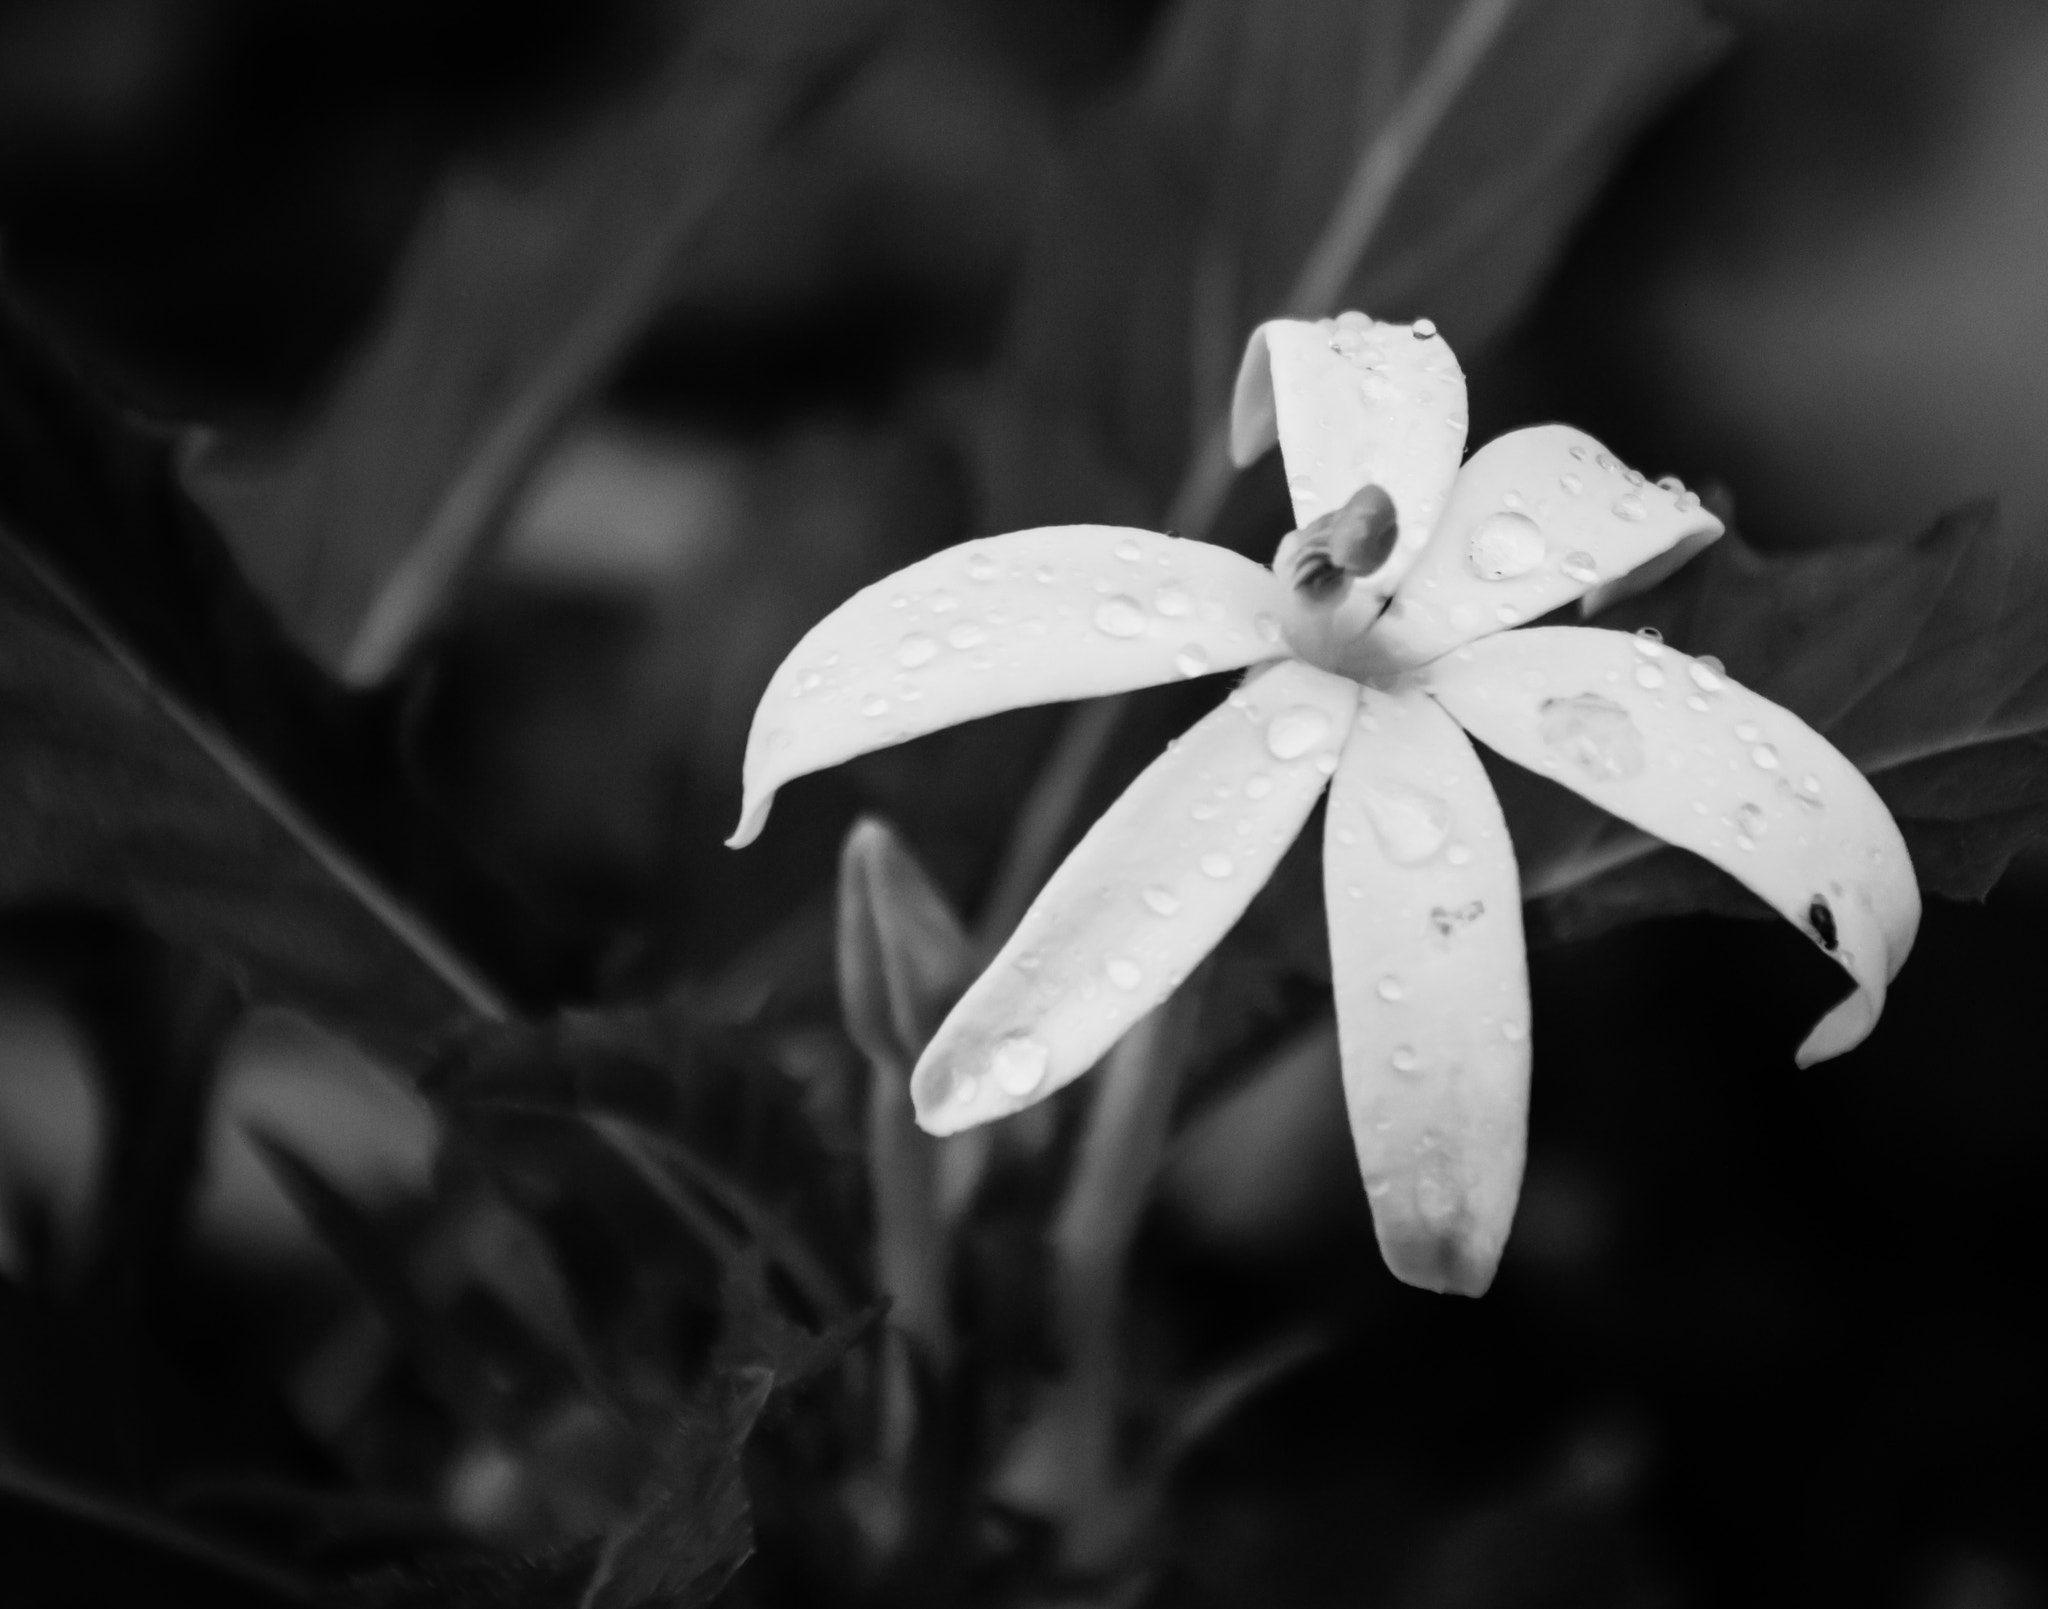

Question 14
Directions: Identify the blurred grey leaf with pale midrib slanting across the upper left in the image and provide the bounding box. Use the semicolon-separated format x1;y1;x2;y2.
195;0;892;682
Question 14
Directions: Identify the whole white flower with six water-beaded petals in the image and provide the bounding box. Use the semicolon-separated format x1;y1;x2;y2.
733;313;1919;1294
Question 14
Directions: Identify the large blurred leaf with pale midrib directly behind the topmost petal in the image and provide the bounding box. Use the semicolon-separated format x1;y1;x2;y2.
983;0;1724;534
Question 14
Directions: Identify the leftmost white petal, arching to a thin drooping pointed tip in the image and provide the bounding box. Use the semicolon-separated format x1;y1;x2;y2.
729;526;1286;847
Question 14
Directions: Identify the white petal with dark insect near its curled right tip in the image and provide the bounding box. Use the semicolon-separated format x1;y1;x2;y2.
1419;626;1919;1067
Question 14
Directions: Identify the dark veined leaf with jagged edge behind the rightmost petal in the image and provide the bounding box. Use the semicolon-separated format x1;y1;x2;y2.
1513;504;2048;938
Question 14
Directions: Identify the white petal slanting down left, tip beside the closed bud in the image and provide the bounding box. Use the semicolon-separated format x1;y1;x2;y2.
911;659;1358;1134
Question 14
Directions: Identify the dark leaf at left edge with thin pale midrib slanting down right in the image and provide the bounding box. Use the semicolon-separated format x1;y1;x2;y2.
0;296;577;1067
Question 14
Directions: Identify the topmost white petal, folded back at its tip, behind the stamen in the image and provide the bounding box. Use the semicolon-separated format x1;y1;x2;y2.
1231;313;1464;598
